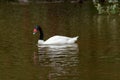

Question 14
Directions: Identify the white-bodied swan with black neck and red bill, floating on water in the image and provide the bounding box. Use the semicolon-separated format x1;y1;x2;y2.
33;25;78;44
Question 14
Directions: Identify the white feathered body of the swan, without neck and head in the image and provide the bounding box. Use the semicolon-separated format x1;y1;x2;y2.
38;36;78;44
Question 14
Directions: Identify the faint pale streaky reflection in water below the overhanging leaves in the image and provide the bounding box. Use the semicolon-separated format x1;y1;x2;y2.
94;16;119;40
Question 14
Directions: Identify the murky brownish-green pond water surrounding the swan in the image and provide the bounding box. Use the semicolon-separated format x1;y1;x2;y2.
0;4;120;80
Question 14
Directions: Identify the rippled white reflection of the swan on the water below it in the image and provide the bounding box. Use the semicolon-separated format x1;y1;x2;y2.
35;44;79;80
